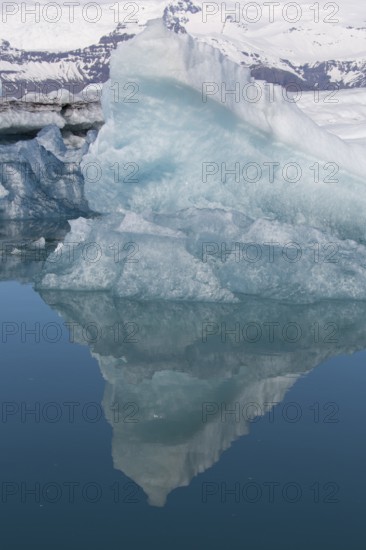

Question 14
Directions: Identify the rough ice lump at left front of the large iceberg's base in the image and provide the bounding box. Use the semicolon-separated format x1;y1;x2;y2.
39;217;234;301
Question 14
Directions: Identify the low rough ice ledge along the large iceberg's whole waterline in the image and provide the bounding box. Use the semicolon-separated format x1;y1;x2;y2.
38;208;366;303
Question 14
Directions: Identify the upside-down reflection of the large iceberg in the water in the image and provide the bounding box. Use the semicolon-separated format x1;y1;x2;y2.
1;224;366;506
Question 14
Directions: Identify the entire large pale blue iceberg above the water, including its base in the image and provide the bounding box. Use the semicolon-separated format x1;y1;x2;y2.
39;20;366;302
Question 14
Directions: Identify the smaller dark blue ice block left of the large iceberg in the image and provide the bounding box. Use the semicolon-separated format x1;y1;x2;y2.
0;125;93;220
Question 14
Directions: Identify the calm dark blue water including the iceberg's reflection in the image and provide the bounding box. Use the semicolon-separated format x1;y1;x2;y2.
0;222;366;550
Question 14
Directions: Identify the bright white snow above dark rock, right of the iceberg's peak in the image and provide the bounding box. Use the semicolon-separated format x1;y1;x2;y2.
175;0;366;64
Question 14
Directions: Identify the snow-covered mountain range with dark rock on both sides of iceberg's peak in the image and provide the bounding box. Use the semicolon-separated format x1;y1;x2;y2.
0;0;366;98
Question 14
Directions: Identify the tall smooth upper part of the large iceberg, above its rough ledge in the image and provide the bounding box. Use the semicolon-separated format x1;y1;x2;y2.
83;21;366;244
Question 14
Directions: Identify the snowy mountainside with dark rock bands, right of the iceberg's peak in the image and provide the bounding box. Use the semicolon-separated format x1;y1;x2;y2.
164;0;366;91
